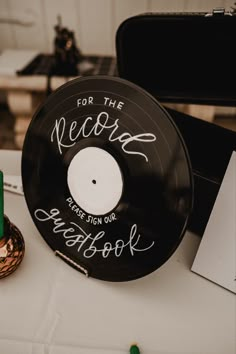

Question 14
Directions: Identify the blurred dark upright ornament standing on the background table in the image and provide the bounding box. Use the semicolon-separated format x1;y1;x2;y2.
53;16;83;76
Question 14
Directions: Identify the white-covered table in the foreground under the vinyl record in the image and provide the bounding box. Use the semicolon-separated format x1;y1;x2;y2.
0;150;236;354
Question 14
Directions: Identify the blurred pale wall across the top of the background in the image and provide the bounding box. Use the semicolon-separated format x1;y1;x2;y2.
0;0;234;54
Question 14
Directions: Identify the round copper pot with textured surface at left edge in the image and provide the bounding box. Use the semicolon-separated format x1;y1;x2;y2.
0;216;25;279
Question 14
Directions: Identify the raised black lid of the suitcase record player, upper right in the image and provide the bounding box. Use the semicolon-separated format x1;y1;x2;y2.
116;13;236;106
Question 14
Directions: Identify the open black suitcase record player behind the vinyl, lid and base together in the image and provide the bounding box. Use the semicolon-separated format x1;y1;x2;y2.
116;8;236;235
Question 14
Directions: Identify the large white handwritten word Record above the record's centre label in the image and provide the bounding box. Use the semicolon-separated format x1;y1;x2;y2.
51;112;156;162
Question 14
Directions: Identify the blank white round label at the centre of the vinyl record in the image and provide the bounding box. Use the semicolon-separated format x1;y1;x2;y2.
67;147;123;215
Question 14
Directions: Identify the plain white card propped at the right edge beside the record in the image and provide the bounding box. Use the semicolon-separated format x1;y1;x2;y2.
191;152;236;293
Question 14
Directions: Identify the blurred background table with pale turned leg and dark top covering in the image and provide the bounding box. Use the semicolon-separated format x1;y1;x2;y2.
0;50;117;149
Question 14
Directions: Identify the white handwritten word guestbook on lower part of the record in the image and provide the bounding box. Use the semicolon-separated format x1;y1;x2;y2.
34;208;155;258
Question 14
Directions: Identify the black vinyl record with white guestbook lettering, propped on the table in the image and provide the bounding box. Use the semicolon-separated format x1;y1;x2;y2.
22;76;193;281
